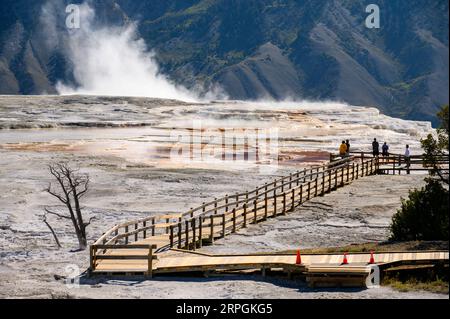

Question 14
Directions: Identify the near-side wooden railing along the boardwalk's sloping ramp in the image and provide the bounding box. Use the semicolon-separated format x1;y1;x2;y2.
169;158;376;250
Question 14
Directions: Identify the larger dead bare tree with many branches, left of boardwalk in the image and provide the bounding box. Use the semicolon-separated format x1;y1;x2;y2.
45;163;94;250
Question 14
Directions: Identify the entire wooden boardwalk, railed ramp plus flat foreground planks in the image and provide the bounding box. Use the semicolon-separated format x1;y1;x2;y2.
90;154;448;284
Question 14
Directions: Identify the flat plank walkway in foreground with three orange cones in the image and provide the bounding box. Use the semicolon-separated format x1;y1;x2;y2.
93;250;449;274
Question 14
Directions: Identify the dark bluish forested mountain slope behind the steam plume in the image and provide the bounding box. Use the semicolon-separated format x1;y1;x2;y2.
0;0;449;125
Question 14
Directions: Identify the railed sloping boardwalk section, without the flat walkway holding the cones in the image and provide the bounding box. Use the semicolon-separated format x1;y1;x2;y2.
90;153;448;276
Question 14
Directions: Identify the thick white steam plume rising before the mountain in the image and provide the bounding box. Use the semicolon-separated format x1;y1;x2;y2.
49;3;204;101
